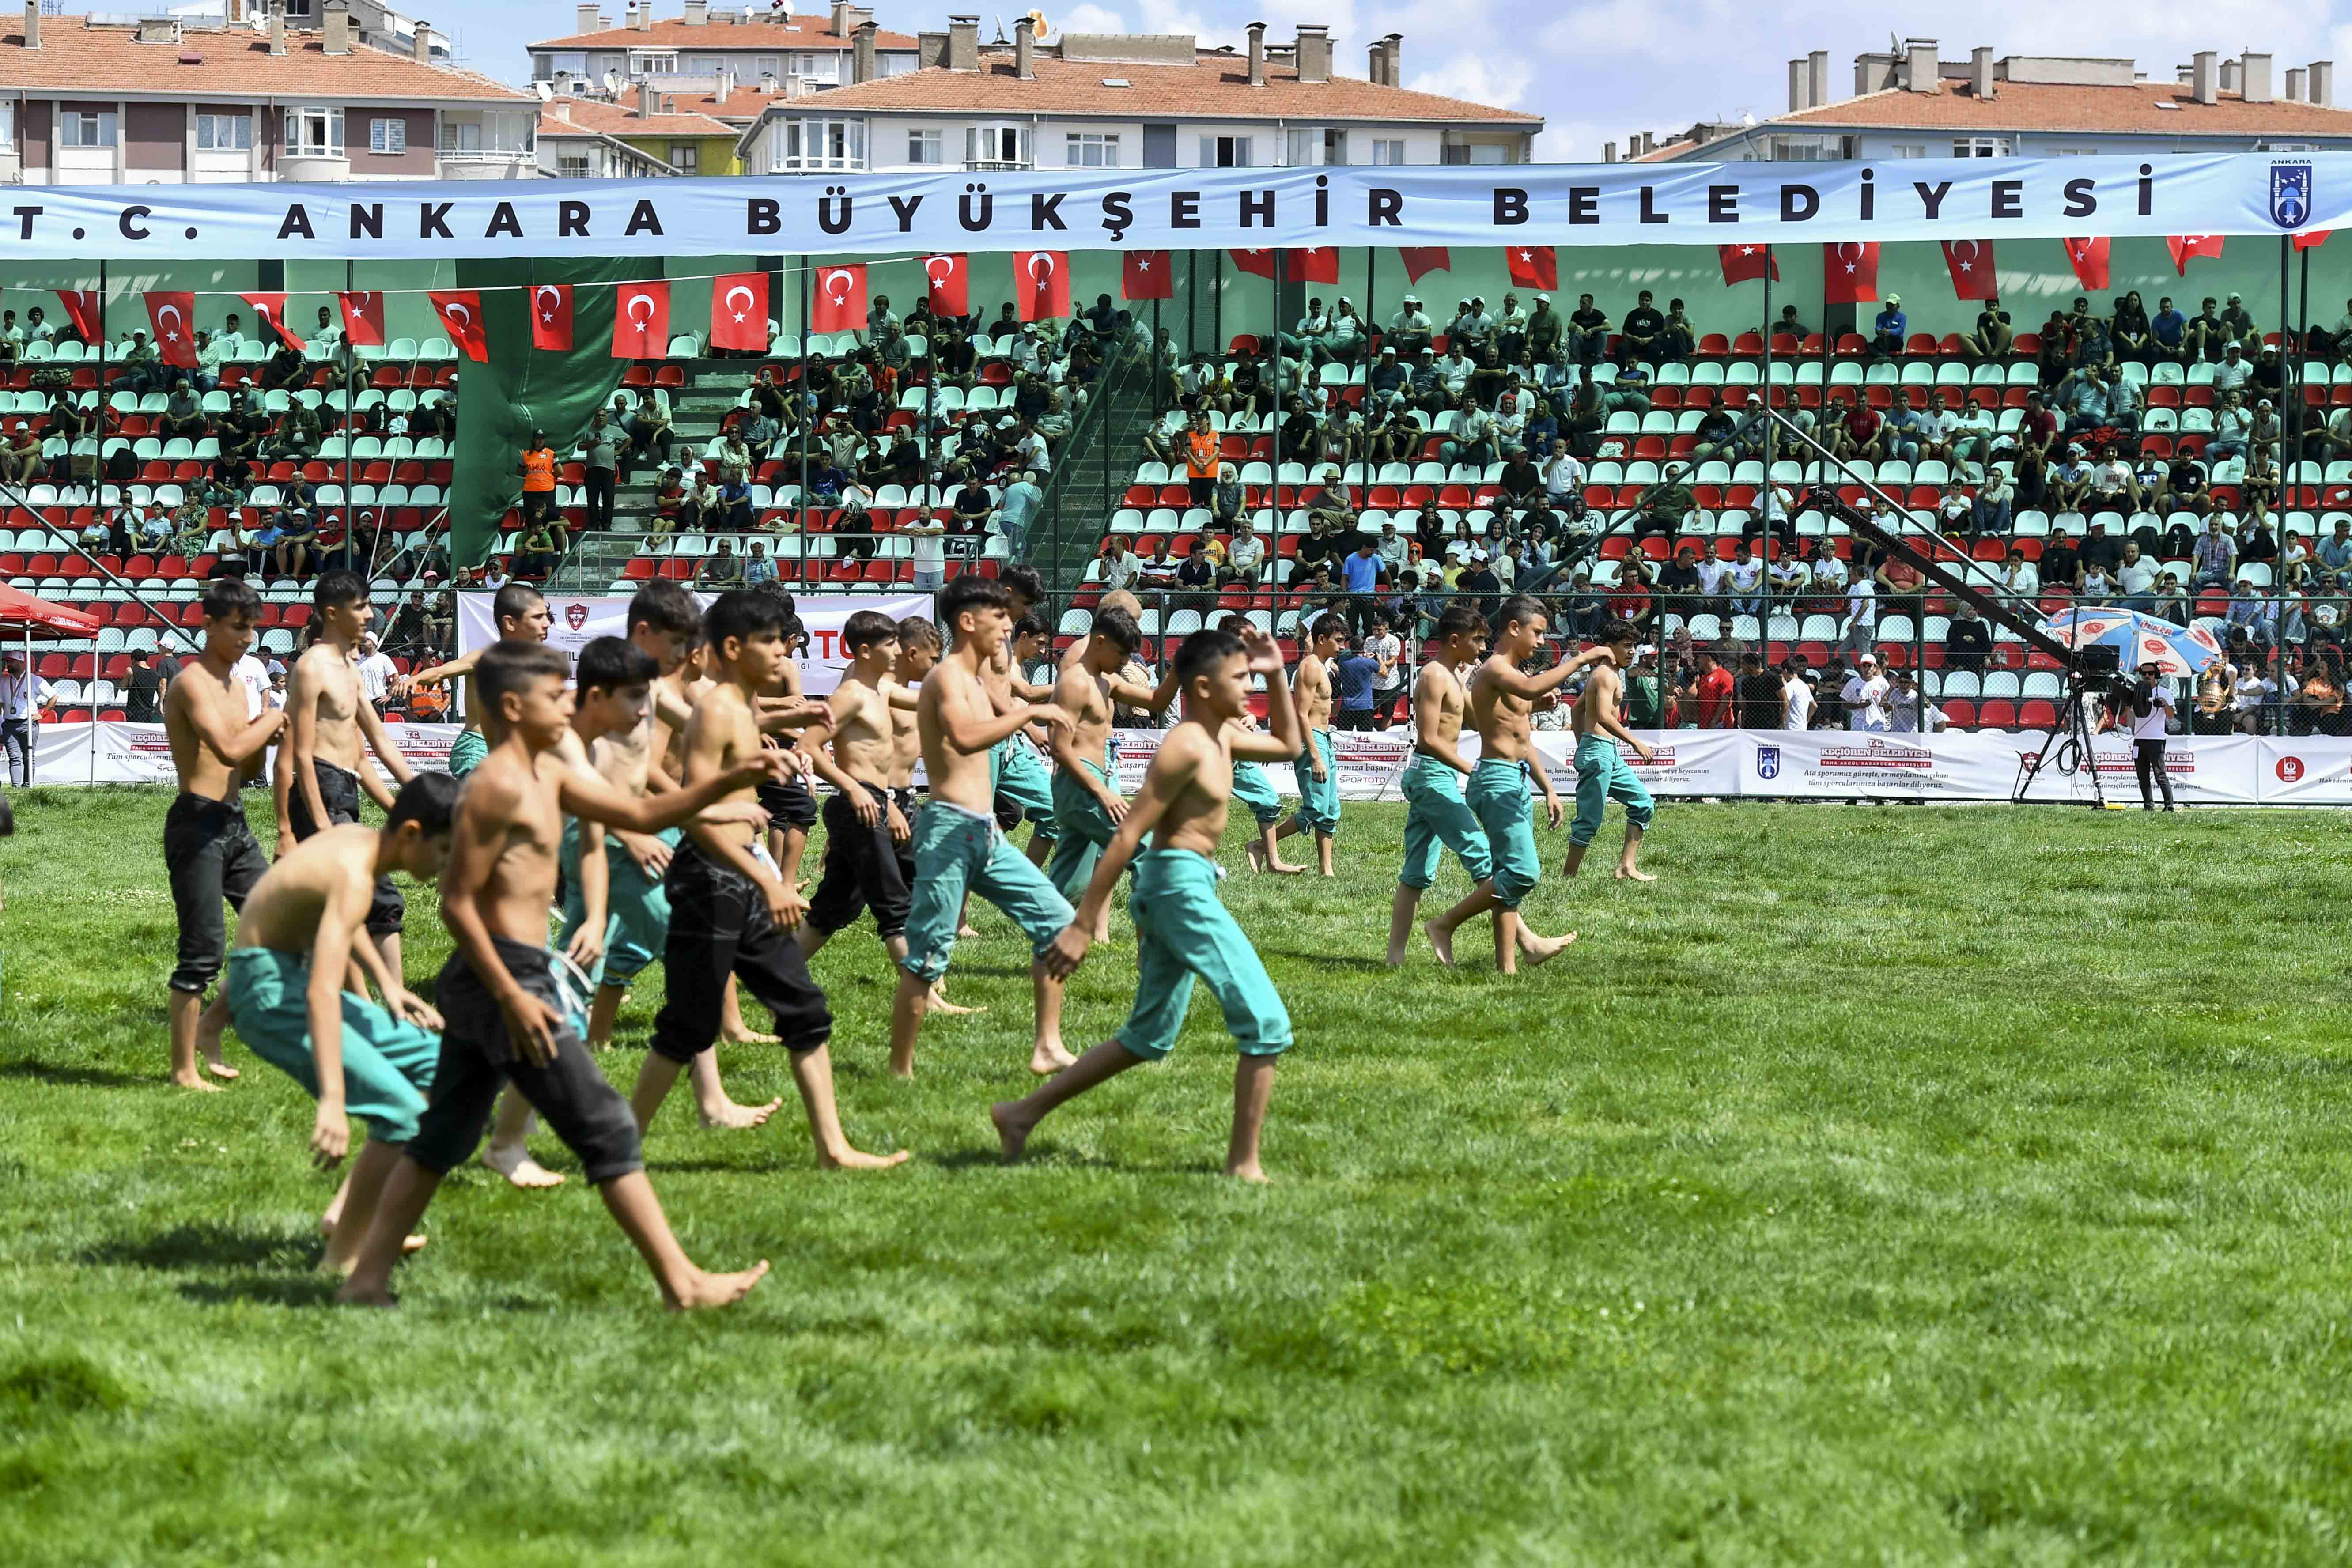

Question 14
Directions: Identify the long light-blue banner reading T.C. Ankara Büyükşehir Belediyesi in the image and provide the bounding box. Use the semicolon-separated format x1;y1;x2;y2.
0;153;2352;263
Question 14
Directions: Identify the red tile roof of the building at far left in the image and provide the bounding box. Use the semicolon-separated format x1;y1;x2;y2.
0;16;532;103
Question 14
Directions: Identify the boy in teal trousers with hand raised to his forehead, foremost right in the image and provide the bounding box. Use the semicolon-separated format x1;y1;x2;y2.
988;627;1301;1183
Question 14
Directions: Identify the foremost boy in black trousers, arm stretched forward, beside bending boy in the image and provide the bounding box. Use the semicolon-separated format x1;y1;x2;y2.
337;642;783;1307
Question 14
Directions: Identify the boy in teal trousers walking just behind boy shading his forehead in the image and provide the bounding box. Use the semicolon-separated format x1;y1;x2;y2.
889;574;1070;1077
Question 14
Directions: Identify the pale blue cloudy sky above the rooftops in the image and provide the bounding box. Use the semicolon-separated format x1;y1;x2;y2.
432;0;2352;162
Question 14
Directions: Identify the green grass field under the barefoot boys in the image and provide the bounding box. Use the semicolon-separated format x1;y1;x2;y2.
0;790;2352;1568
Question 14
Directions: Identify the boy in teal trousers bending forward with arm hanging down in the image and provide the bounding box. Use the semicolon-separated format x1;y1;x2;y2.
226;774;459;1274
